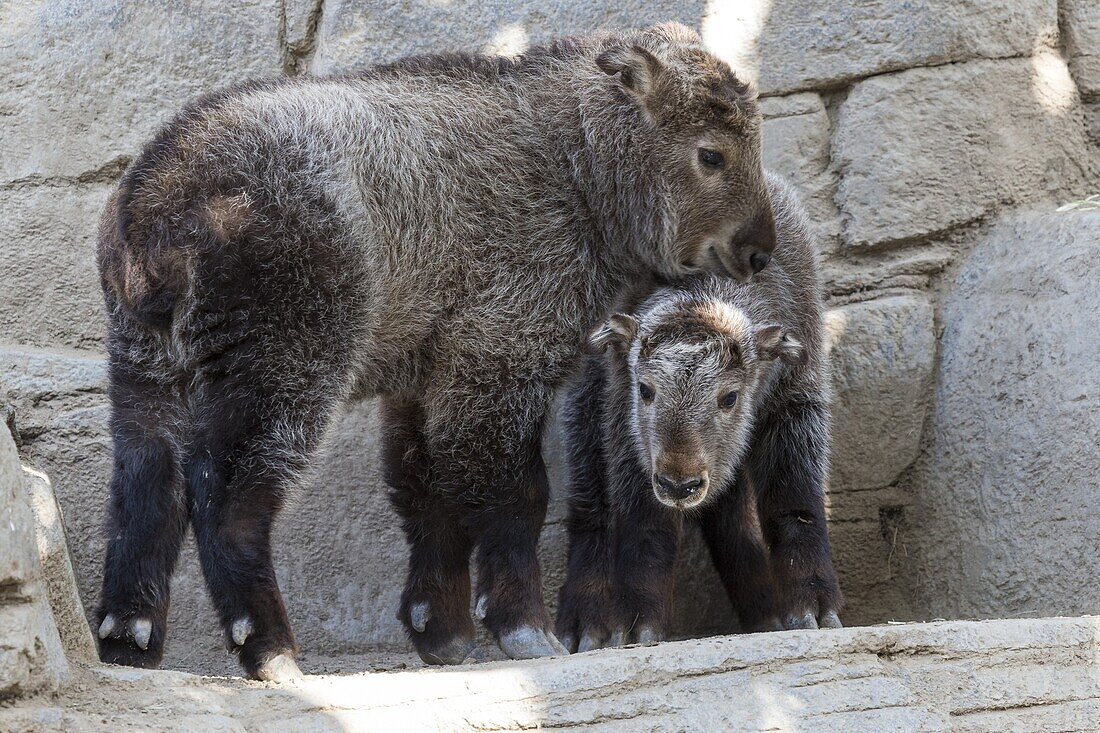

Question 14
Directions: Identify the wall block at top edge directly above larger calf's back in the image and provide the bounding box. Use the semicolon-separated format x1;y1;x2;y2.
312;0;706;74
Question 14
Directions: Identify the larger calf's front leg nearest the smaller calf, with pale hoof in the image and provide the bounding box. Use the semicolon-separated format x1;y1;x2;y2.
425;374;568;659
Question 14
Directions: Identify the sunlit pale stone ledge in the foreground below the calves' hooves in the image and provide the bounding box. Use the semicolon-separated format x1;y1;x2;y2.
0;617;1100;733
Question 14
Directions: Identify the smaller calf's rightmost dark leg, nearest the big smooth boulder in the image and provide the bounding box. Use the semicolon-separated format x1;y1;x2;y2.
749;397;843;628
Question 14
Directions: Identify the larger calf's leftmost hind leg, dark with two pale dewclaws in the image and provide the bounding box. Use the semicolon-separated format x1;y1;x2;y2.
95;324;188;667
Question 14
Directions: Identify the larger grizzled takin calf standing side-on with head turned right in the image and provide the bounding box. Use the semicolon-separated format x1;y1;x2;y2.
98;25;774;679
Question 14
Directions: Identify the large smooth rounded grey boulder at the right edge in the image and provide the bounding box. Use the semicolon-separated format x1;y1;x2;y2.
910;212;1100;617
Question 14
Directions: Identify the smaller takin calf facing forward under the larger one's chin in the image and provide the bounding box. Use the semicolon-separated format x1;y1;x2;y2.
557;177;842;652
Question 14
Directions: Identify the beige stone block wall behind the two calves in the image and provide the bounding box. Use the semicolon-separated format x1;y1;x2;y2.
0;0;1100;671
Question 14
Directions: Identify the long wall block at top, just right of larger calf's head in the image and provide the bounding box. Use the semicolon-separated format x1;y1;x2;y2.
703;0;1056;95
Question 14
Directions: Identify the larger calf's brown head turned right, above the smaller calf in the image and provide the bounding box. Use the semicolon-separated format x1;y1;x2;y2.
596;23;776;281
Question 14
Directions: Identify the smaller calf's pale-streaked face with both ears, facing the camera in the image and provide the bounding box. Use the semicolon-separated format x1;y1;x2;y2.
587;299;804;510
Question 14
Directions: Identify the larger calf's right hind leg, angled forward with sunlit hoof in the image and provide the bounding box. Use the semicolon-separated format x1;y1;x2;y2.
185;360;334;681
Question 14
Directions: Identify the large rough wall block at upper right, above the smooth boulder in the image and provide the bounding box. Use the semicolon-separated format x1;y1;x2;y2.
833;54;1097;248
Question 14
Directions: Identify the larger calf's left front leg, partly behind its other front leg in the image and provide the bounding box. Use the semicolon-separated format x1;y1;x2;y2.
382;400;475;665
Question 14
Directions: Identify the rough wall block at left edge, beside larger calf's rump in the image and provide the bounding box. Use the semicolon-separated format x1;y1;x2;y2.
0;184;111;348
